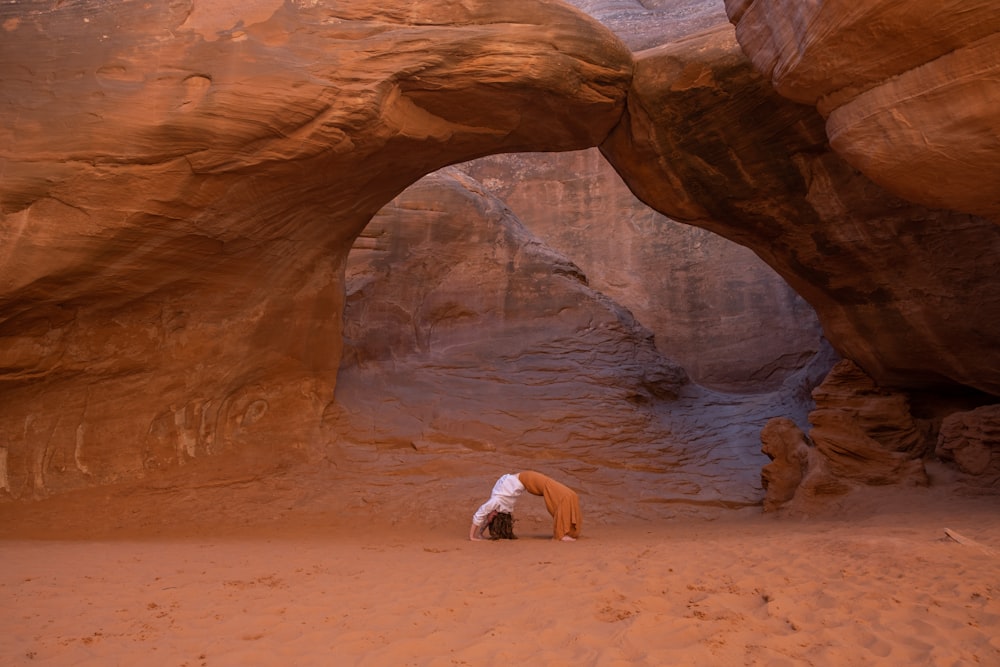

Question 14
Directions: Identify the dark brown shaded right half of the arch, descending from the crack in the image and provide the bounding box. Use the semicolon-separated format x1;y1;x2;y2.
601;19;1000;395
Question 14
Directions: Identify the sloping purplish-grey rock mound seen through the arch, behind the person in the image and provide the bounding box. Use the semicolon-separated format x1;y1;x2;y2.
336;169;830;512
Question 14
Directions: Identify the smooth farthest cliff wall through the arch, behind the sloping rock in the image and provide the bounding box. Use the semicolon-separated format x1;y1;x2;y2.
461;150;821;392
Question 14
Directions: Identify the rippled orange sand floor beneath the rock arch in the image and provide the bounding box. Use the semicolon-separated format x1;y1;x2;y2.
0;460;1000;667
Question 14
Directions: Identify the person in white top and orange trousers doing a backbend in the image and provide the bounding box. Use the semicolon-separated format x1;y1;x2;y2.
469;470;580;542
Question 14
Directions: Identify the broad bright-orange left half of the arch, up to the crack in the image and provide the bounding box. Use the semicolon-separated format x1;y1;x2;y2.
0;1;631;497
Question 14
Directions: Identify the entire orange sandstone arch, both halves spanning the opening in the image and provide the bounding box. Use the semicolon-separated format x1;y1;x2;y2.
0;0;1000;497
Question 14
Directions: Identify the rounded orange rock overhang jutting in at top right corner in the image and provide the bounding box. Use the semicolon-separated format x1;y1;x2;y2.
726;0;1000;220
